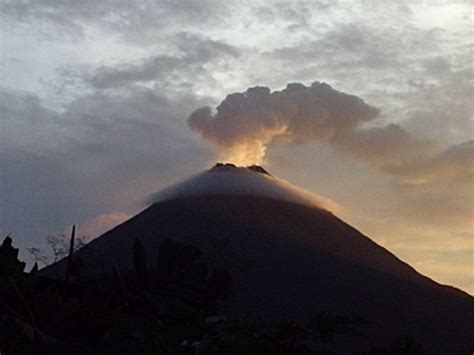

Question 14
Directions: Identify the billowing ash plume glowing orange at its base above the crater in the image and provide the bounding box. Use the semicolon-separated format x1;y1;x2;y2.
188;82;379;165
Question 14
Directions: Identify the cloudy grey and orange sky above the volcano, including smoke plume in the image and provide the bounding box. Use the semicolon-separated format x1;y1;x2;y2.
0;0;474;294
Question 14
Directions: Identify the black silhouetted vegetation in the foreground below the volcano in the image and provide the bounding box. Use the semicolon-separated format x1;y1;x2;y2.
0;238;424;355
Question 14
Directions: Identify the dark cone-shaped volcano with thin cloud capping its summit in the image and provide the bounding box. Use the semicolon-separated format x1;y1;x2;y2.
42;164;474;354
